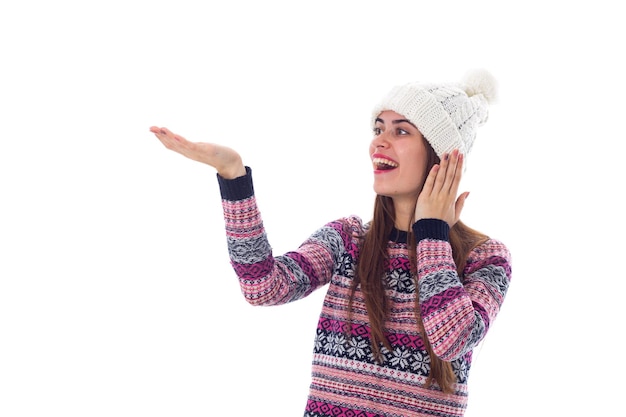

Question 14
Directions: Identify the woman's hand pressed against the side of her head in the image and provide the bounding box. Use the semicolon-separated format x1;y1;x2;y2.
415;150;469;227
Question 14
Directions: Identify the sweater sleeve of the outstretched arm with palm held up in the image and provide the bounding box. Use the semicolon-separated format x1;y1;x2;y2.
218;167;345;305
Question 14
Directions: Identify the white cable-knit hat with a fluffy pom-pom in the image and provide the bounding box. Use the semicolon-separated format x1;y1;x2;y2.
372;69;497;157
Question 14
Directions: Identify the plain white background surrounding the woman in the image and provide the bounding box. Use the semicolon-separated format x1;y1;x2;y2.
0;0;626;417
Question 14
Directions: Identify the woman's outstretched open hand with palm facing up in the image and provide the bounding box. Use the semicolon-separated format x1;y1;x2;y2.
150;126;246;179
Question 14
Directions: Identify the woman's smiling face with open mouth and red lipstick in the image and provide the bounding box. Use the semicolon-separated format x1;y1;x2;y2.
370;110;427;203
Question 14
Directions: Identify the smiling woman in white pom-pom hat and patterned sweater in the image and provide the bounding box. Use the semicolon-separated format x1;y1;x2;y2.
150;71;511;417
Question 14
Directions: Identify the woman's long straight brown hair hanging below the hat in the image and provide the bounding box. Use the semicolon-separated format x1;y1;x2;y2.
348;141;487;393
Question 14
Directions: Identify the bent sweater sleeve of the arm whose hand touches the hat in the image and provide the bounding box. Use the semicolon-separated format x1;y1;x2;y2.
413;219;511;361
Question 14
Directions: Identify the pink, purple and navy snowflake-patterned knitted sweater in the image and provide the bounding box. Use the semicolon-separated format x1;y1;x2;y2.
218;168;511;417
